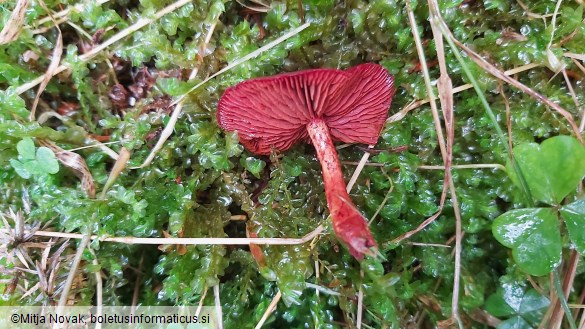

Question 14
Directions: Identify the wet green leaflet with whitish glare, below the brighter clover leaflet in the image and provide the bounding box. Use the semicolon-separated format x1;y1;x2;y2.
492;208;561;276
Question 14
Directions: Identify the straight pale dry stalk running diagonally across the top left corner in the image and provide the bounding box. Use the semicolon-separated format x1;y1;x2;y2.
15;0;192;94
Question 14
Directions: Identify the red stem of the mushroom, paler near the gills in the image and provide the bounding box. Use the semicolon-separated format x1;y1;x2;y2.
307;119;376;260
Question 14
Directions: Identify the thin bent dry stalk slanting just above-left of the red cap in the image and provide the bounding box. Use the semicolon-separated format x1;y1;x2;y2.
136;23;310;169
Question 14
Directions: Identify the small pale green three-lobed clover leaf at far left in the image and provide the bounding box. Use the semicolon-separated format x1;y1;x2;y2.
10;138;59;179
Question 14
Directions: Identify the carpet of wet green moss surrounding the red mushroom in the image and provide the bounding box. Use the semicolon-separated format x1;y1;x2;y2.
0;0;585;328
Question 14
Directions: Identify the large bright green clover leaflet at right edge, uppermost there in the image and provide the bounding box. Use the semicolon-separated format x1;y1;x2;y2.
506;136;585;205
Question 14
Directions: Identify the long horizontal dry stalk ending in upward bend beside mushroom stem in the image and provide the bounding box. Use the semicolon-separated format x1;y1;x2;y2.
0;225;325;245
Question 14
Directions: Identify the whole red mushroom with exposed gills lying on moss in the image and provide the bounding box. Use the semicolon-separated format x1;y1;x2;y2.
217;64;394;260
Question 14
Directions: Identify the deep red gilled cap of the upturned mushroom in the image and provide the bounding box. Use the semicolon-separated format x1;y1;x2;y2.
217;63;394;154
